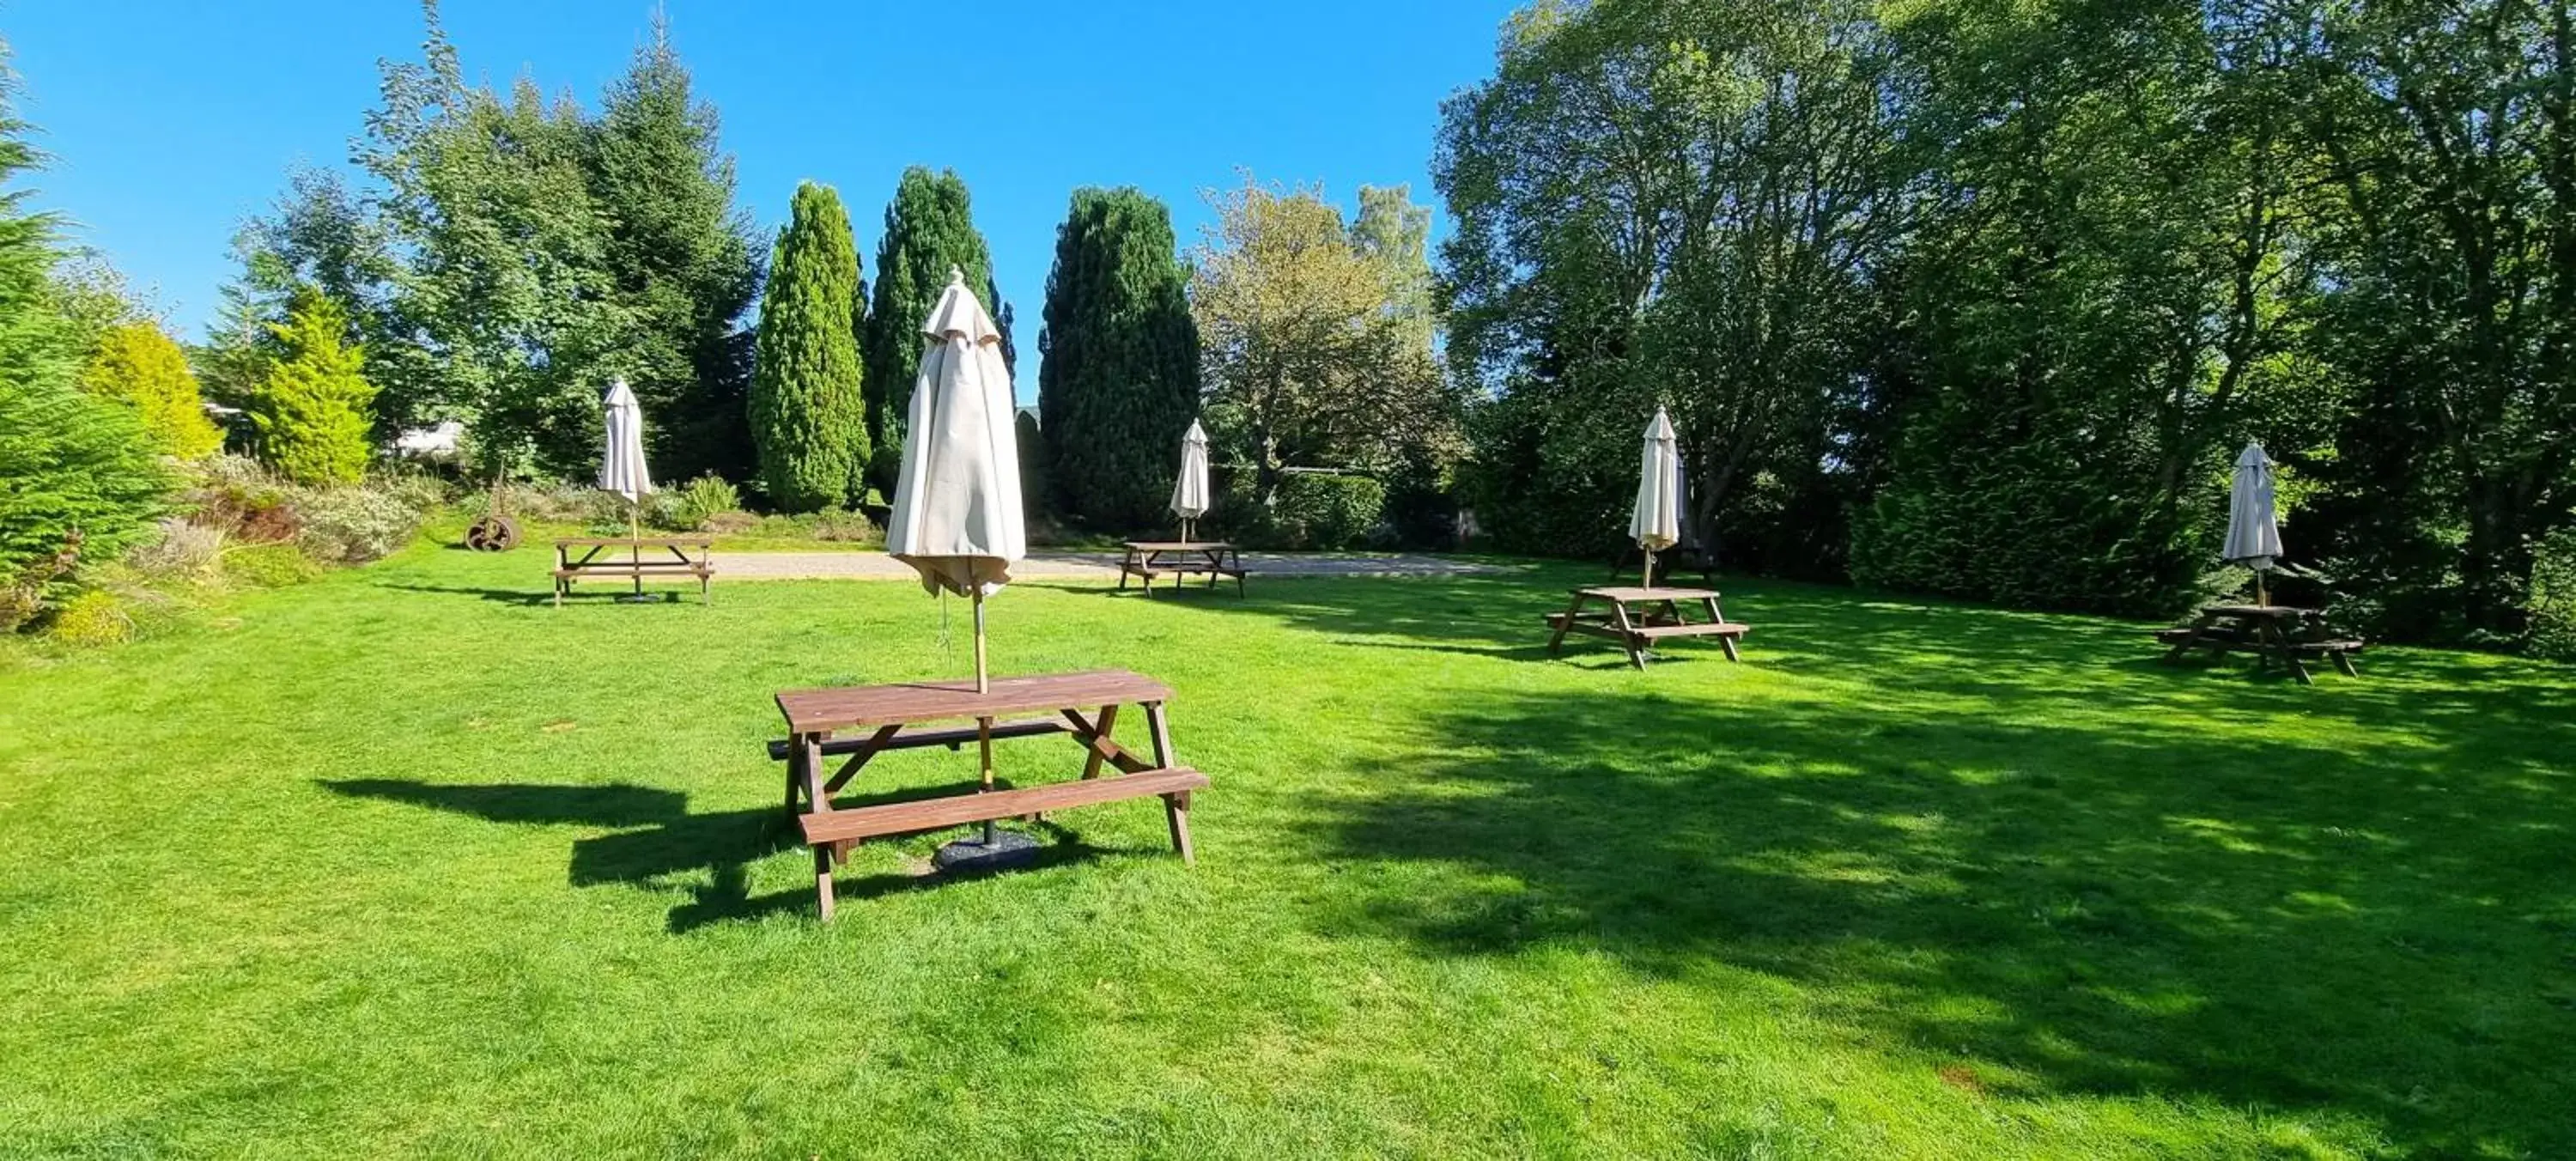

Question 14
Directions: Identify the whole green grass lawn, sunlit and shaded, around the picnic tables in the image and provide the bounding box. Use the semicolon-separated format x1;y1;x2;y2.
0;546;2576;1158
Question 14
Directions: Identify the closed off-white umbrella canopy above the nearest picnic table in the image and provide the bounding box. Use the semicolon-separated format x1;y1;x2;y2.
886;268;1028;597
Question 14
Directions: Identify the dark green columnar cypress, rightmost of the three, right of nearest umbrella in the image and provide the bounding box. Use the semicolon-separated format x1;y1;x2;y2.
1038;188;1198;531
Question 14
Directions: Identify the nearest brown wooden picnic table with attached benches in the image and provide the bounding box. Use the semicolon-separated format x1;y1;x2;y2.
770;669;1208;919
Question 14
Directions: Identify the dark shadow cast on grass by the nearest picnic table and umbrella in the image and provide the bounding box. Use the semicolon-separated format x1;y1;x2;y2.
322;777;1115;934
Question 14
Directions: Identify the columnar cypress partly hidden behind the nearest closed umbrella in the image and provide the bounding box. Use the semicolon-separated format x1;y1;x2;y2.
866;165;1005;463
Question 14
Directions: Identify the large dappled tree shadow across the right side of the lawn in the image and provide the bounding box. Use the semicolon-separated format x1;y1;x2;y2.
1314;653;2576;1156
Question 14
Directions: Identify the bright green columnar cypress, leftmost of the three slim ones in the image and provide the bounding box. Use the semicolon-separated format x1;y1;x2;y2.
750;183;868;513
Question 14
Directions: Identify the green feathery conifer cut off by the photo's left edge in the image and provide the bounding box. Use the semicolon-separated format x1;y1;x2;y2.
0;44;170;625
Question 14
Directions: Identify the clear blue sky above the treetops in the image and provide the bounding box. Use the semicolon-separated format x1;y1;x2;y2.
0;0;1512;397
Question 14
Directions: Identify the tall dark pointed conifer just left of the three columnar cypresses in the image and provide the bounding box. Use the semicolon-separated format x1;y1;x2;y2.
585;15;760;479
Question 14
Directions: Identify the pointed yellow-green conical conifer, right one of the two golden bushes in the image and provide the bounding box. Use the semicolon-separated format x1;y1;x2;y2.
250;291;376;484
